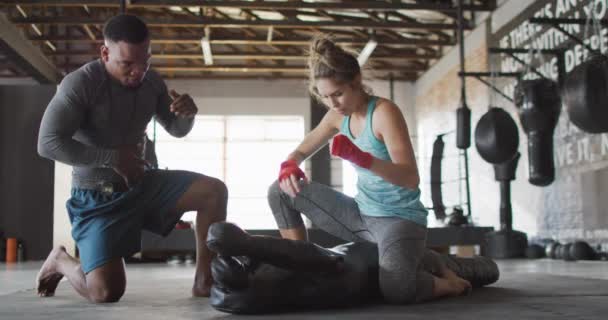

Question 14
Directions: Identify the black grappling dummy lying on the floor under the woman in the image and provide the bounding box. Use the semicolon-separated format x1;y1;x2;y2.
207;222;500;314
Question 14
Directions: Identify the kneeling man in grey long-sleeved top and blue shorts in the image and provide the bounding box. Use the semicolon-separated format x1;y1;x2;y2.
37;15;228;302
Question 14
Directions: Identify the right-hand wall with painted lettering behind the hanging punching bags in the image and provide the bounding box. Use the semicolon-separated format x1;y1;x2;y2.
415;0;608;248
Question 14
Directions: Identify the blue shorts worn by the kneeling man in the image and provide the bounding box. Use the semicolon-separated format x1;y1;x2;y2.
66;170;202;273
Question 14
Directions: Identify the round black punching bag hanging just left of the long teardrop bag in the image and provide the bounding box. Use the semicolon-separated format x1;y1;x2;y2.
475;107;519;164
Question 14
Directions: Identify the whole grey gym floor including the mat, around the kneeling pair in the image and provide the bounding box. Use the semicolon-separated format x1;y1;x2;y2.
0;259;608;320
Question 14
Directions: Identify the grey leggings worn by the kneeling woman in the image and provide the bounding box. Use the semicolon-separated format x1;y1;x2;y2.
268;182;443;304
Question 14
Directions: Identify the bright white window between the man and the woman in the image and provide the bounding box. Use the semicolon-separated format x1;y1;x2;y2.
148;116;304;229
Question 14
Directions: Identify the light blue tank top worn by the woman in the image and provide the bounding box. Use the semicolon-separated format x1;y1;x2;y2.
340;97;428;226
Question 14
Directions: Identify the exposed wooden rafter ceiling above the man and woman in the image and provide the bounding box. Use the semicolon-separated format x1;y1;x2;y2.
0;0;496;80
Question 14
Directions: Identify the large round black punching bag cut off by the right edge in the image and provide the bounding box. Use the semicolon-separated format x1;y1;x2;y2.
562;55;608;133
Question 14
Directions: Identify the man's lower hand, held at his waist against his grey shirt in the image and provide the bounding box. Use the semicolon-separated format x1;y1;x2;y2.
113;144;149;187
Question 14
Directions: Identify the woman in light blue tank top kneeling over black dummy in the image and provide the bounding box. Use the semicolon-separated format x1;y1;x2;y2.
268;36;471;303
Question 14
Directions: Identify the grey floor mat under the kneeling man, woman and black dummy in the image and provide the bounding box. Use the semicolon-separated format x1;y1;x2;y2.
0;273;608;320
